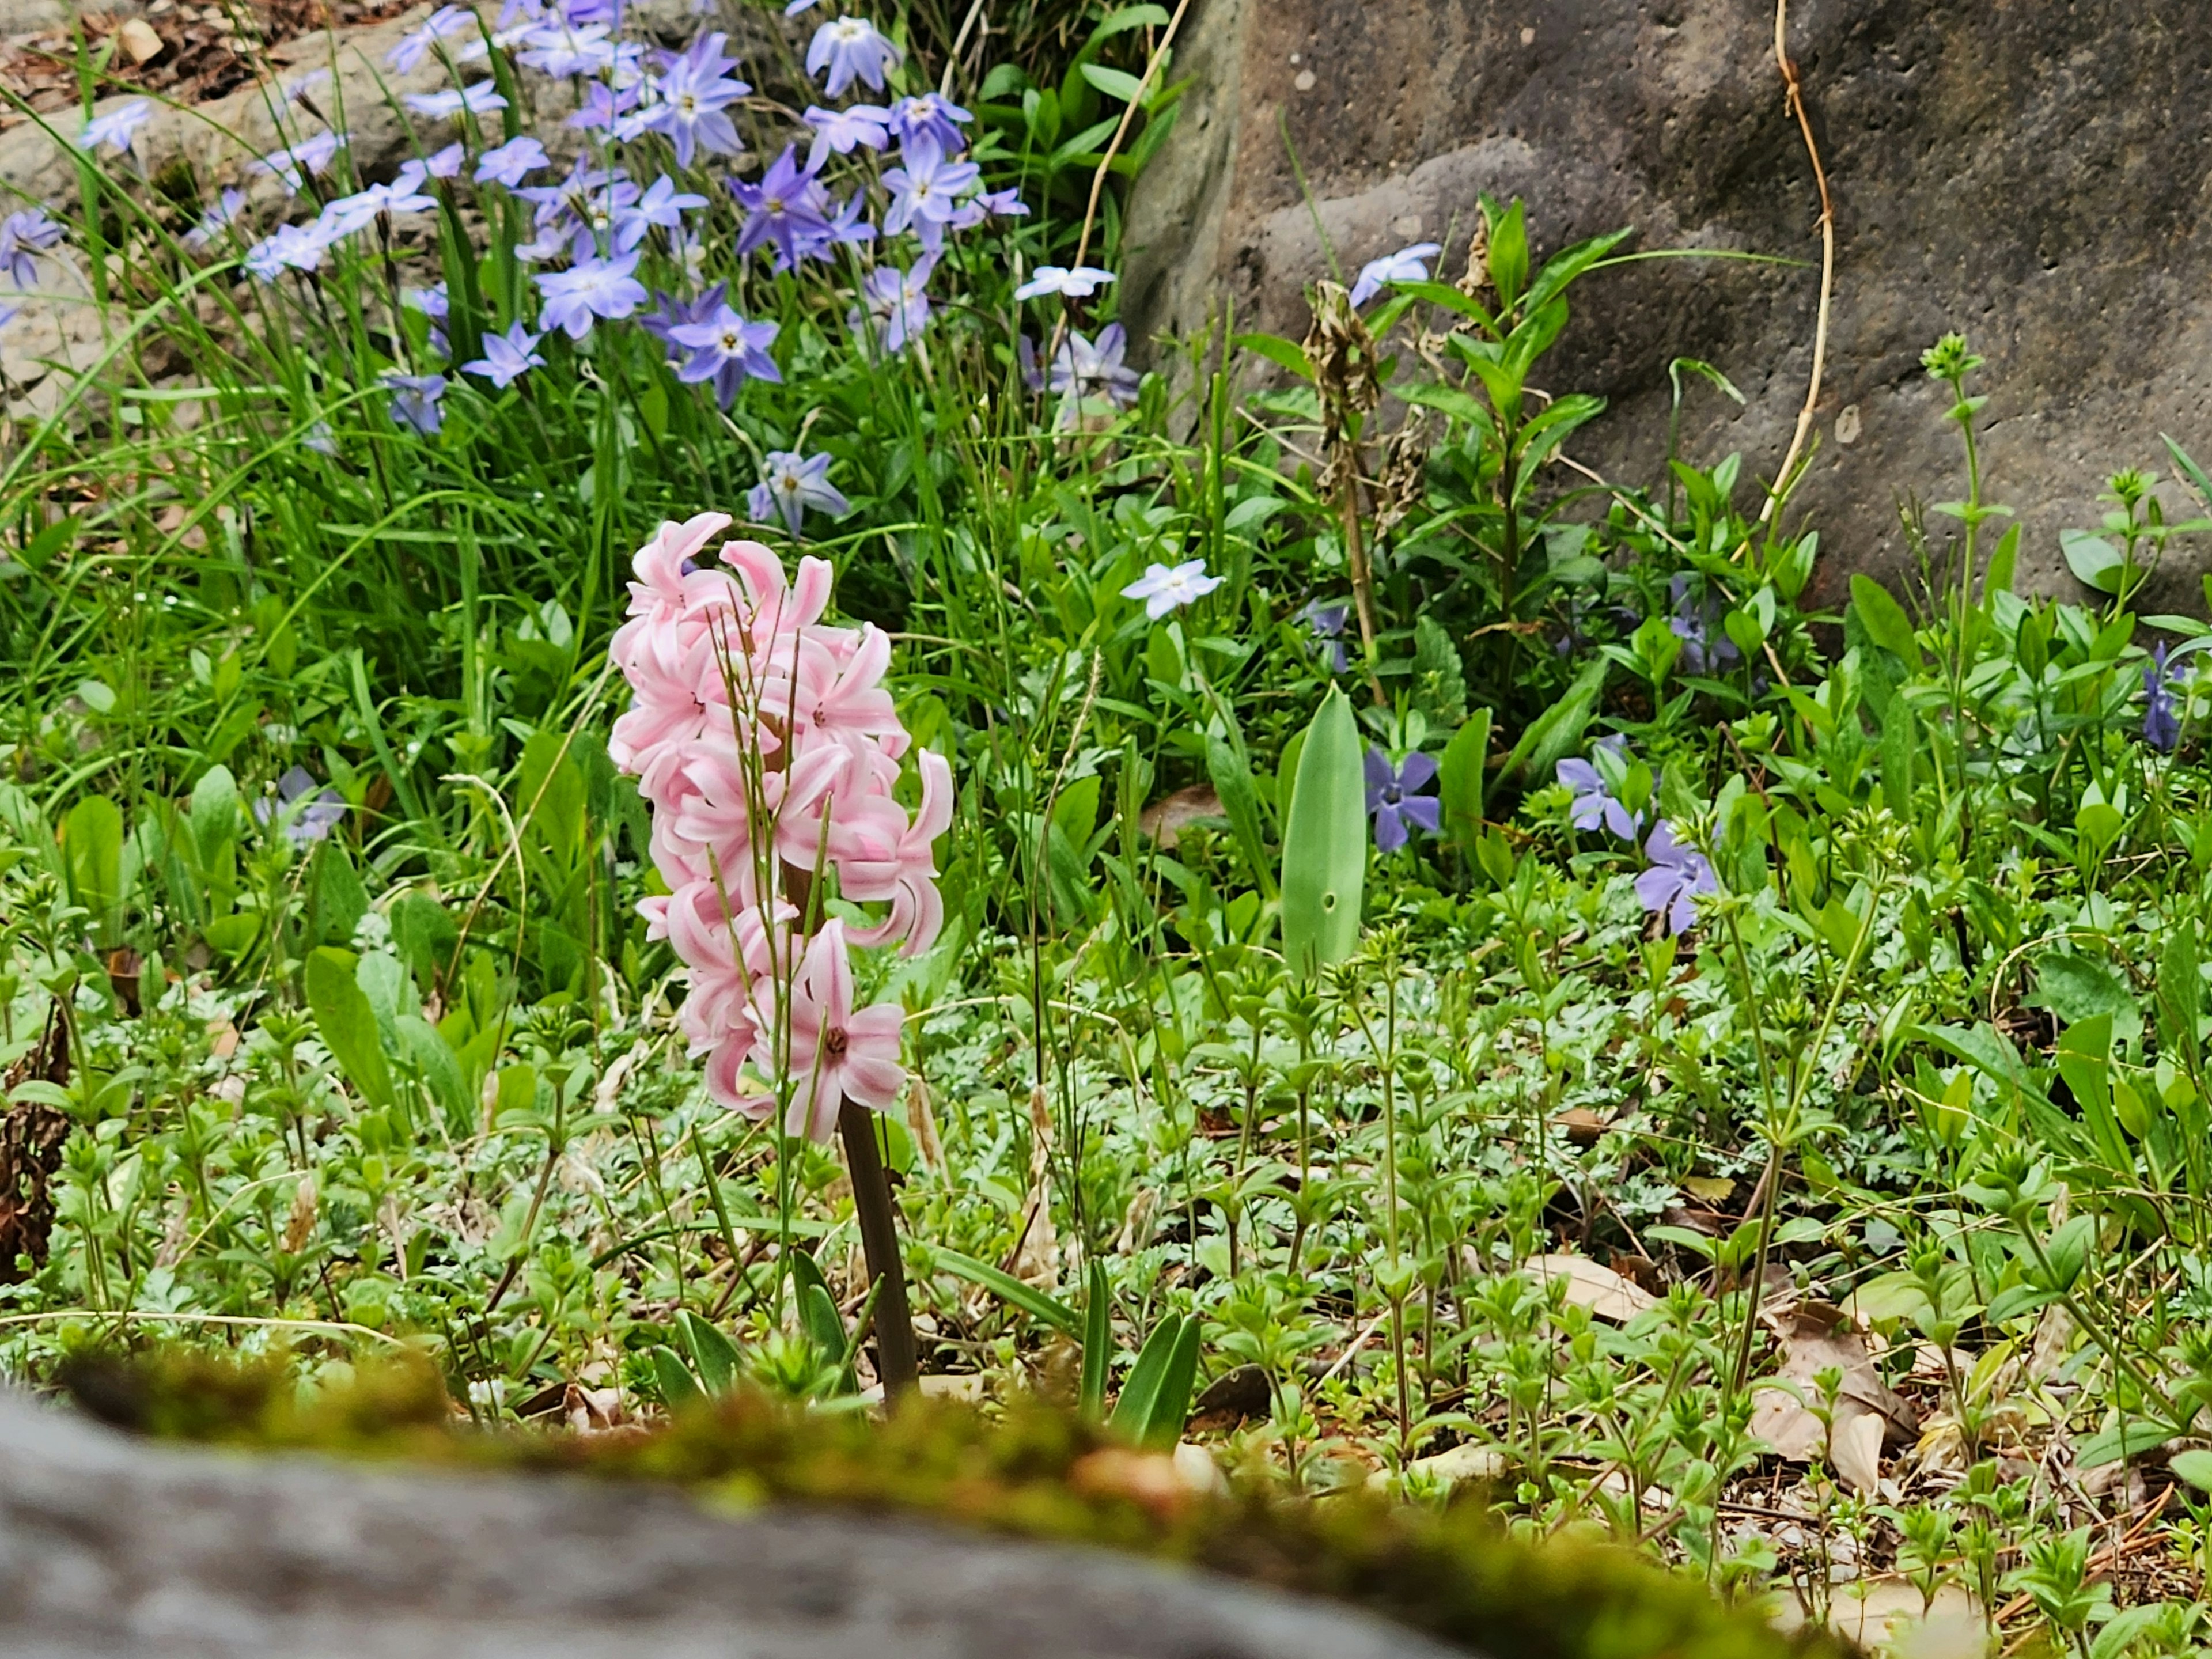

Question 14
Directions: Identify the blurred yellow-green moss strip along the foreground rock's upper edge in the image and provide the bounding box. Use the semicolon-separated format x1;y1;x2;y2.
69;1351;1834;1659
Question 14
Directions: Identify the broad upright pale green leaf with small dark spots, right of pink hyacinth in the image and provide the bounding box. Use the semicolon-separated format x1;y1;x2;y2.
1283;685;1367;978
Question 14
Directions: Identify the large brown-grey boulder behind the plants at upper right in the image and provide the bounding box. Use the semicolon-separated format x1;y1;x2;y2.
1124;0;2212;608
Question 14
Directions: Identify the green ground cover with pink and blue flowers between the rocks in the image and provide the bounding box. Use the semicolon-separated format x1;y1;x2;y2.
0;0;2212;1659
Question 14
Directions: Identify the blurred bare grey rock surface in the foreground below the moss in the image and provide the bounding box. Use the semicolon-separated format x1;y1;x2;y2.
0;1396;1446;1659
